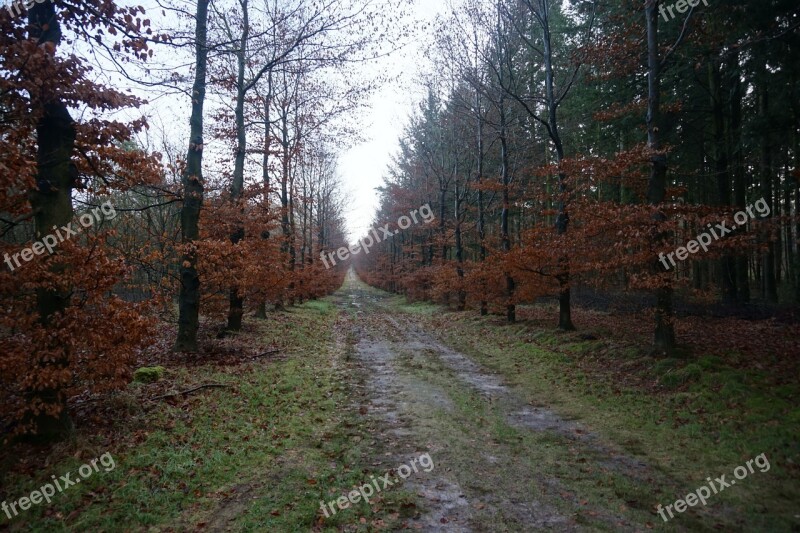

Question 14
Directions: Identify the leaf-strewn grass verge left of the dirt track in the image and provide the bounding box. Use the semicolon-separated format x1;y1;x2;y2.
0;301;418;531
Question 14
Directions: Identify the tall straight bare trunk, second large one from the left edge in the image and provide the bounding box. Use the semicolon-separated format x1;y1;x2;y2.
175;0;209;352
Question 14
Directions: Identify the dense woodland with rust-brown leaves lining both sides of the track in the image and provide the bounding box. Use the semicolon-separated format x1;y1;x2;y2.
0;0;800;438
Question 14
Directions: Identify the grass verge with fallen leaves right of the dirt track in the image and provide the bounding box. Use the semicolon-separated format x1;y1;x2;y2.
398;304;800;531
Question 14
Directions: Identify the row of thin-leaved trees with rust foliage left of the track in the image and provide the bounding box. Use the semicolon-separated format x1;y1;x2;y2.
0;0;390;439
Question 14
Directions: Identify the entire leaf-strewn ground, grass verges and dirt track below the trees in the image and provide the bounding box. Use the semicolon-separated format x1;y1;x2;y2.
0;272;800;532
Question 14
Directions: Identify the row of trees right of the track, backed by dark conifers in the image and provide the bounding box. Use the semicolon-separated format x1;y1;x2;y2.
357;0;800;352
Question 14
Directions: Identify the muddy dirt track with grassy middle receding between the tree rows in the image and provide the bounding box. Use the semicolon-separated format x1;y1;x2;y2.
324;270;647;532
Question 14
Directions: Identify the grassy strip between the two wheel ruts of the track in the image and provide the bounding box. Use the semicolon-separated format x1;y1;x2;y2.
390;332;664;532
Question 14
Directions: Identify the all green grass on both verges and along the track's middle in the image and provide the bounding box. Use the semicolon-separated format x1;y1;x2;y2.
0;290;800;532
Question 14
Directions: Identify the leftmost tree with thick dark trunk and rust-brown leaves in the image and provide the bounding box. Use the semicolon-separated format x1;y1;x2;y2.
0;0;161;440
